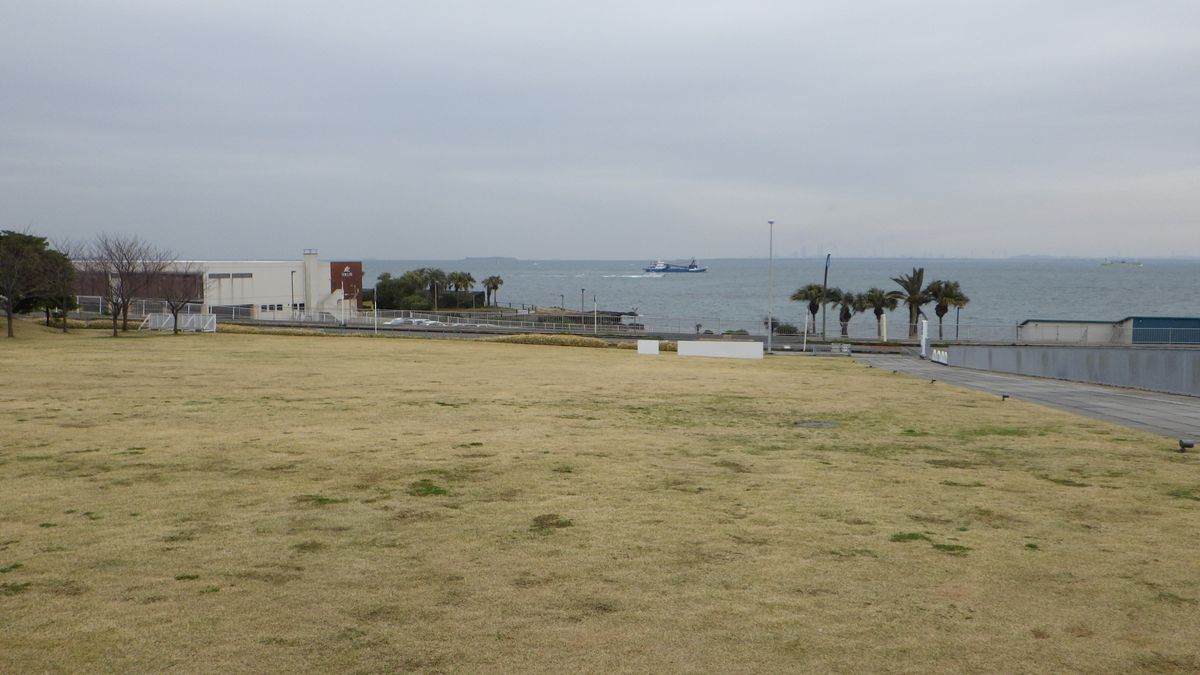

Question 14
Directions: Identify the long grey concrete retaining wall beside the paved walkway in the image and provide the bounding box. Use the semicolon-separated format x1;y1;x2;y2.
949;345;1200;396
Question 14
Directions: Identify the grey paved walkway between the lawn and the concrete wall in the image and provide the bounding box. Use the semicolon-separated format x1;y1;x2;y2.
856;354;1200;440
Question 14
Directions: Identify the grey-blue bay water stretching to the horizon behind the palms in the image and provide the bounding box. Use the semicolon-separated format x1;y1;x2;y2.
364;258;1200;335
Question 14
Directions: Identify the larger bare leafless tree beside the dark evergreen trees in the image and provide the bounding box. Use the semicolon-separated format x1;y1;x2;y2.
88;234;175;338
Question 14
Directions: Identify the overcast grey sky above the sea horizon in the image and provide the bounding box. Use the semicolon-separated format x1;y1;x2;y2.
0;0;1200;259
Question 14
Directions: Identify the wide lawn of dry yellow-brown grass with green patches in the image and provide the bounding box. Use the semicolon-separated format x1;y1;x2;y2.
0;319;1200;673
